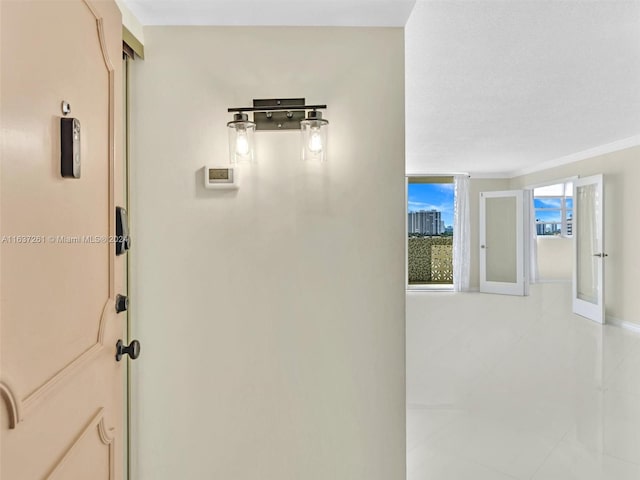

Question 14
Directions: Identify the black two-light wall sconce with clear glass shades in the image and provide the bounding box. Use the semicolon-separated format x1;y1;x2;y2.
227;98;329;163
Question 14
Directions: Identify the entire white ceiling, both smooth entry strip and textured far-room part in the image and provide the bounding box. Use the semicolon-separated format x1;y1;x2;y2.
124;0;640;175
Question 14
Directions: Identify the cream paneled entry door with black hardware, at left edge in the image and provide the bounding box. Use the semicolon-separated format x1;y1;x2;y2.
0;0;125;480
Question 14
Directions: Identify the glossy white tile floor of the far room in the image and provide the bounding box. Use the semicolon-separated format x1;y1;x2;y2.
407;284;640;480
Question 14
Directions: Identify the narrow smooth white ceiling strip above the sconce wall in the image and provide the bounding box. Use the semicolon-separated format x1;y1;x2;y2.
123;0;415;27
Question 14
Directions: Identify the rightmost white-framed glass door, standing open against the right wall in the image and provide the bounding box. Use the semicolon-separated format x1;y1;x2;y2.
573;175;606;323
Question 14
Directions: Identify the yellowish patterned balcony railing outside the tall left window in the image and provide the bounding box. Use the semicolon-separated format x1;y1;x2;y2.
407;237;453;285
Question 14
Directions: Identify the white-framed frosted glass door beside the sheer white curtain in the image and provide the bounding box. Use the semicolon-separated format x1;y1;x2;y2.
480;190;528;295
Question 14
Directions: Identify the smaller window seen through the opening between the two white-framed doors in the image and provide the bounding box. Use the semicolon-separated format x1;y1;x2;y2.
533;182;573;237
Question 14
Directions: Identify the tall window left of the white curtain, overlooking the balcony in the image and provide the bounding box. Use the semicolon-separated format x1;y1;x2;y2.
407;176;454;286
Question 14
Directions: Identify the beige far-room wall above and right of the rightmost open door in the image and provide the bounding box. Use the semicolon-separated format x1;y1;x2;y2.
511;147;640;323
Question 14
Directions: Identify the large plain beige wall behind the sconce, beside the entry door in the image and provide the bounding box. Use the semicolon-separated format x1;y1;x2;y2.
131;27;406;480
